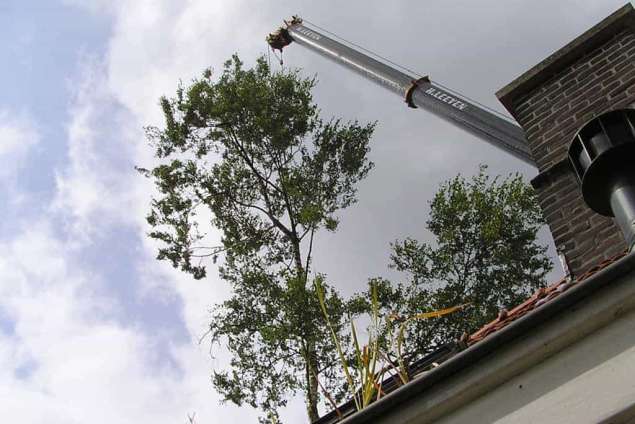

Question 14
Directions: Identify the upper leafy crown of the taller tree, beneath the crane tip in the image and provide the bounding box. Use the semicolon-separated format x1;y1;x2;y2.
140;56;374;284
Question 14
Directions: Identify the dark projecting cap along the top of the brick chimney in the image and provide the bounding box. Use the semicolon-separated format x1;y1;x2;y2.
496;3;635;111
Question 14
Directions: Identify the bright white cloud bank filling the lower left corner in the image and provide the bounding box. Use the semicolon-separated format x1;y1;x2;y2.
0;222;255;424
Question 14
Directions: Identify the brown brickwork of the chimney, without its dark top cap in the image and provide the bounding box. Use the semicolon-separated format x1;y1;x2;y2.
500;23;635;275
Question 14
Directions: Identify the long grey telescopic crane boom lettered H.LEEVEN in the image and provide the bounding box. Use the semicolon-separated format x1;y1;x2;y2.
267;17;536;166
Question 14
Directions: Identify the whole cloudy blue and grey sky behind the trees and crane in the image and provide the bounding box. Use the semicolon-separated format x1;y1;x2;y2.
0;0;624;424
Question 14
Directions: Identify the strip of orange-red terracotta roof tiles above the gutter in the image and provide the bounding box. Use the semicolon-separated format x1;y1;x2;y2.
467;252;627;346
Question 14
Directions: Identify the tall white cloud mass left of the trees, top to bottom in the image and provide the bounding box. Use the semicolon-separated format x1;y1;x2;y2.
9;2;304;424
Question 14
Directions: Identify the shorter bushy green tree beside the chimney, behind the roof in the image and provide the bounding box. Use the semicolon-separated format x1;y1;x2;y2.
373;166;552;360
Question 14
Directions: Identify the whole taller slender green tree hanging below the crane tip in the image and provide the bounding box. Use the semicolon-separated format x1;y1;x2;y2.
140;56;374;421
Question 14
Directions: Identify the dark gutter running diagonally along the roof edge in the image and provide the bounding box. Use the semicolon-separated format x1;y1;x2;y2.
341;255;635;424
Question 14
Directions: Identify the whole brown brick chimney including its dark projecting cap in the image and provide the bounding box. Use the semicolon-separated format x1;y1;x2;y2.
497;4;635;275
